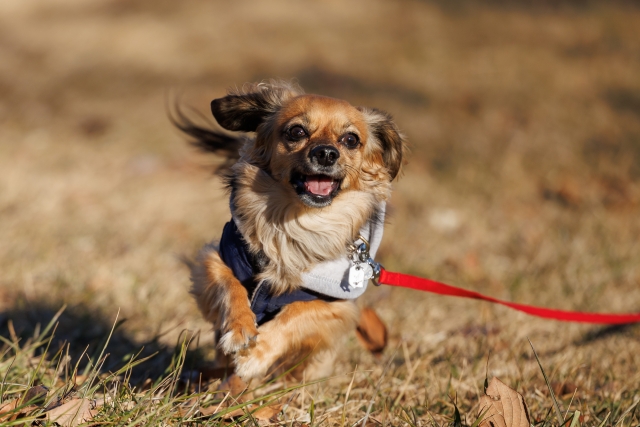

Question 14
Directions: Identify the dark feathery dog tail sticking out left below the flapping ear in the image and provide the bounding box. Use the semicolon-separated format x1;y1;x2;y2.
168;103;246;175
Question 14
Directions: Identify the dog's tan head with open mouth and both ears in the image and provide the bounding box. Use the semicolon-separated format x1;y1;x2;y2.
211;83;404;208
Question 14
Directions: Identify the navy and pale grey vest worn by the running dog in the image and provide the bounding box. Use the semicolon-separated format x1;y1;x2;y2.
218;205;384;325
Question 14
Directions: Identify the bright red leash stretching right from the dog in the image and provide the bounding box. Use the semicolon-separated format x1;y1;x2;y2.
378;269;640;325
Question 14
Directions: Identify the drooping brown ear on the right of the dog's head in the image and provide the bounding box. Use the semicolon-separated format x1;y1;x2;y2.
358;107;406;180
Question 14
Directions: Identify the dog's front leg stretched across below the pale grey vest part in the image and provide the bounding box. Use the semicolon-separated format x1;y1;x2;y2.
234;300;359;381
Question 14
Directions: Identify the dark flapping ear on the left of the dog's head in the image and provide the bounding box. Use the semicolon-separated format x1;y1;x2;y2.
211;82;302;132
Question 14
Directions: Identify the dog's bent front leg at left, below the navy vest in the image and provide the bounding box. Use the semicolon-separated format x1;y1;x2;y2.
191;246;258;354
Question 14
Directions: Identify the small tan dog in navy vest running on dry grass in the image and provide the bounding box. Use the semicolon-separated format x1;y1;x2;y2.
176;81;406;381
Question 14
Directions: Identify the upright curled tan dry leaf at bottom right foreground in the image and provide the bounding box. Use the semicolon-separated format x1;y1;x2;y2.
478;377;531;427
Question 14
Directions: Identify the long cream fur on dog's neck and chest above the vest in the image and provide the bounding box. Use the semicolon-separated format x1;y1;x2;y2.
230;161;390;294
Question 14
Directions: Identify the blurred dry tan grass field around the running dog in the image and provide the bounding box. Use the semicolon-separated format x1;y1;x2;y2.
0;0;640;426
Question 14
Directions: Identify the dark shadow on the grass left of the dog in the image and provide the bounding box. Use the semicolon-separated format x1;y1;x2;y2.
0;300;208;385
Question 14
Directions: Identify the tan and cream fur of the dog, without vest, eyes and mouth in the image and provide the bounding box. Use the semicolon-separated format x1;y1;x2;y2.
179;82;404;380
